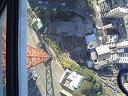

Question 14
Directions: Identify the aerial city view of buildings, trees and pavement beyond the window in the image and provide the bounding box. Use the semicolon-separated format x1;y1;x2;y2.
15;0;128;96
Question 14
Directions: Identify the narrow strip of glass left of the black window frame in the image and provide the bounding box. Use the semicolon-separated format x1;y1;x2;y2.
0;8;7;96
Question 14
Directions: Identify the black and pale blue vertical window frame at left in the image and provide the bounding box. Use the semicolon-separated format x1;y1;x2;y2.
0;0;28;96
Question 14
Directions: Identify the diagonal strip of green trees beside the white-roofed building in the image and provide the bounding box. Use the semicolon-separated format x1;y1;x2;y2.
43;35;102;96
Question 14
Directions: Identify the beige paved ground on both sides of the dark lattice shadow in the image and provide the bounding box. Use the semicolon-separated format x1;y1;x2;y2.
33;55;64;96
